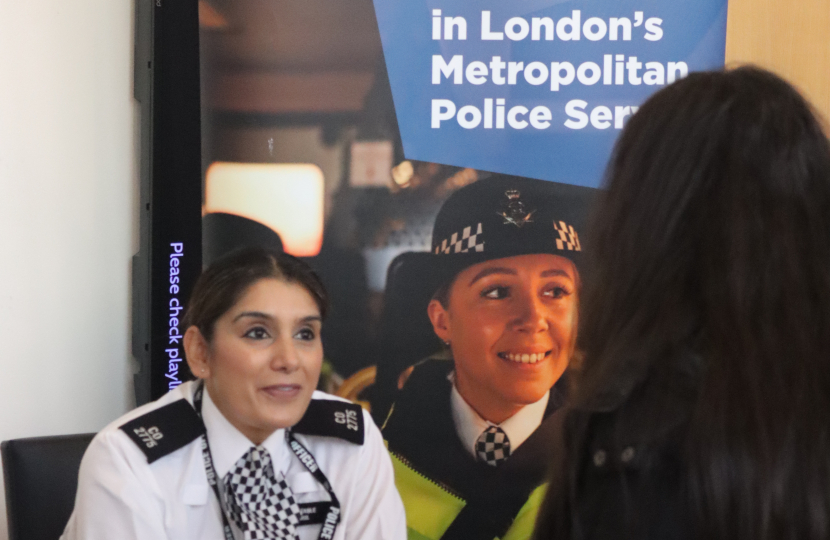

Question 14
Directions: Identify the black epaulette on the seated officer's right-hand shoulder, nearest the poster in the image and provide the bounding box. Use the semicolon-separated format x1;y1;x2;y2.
291;399;364;444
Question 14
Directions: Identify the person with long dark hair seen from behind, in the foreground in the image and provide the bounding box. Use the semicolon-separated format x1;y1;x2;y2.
536;67;830;540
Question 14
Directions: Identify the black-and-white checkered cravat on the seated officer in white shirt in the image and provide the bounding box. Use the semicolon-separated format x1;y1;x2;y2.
225;446;300;540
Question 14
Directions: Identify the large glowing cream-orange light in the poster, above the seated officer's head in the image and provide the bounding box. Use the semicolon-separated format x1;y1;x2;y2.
205;161;325;257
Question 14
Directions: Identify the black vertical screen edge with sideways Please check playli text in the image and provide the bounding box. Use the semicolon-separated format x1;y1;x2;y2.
132;0;202;405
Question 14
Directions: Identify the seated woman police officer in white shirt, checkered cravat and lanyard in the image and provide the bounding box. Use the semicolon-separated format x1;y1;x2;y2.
63;249;405;540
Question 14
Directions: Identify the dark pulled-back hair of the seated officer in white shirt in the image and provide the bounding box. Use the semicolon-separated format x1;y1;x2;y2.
183;248;329;342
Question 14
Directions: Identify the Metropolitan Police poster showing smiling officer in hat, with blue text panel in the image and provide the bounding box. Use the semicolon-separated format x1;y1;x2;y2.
200;0;725;540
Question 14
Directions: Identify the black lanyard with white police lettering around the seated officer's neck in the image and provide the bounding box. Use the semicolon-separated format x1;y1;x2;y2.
193;381;340;540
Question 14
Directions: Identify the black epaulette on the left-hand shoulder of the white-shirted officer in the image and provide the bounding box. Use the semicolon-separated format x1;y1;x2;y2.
119;399;205;463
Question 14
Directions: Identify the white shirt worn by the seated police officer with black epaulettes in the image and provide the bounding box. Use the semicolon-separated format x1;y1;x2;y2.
61;382;406;540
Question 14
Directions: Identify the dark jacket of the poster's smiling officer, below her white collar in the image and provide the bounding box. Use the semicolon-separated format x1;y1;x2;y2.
383;360;565;540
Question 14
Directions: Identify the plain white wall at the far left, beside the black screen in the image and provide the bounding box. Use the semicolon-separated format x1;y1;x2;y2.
0;0;138;540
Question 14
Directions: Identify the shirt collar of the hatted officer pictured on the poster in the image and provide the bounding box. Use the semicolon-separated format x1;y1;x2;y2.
448;372;550;457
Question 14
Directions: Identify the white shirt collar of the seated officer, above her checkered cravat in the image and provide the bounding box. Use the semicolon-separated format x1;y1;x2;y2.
202;388;289;478
